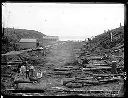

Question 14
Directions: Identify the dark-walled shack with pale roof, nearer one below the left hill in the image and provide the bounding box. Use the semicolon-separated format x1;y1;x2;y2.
19;38;39;50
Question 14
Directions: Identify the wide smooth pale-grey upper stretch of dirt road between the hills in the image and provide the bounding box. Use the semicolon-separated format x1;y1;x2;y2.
46;43;75;67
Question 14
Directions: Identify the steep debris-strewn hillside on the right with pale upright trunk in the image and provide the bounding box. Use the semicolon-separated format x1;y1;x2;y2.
84;26;124;54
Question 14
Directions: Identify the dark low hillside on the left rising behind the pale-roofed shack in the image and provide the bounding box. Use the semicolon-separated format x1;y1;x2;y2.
1;28;46;53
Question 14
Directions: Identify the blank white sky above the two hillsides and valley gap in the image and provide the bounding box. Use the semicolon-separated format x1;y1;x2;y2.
2;3;124;41
